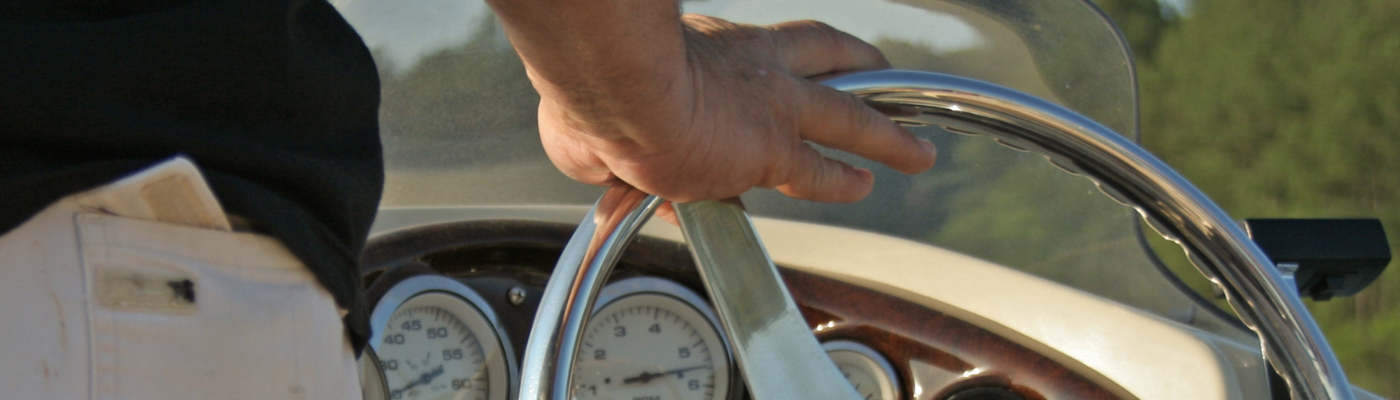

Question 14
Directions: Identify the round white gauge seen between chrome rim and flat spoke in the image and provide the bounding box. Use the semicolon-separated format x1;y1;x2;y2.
573;278;732;400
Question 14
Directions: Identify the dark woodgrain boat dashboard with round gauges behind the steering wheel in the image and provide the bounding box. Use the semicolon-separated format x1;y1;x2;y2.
363;213;1135;400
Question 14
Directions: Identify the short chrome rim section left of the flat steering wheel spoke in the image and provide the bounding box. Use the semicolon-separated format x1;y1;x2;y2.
519;185;662;400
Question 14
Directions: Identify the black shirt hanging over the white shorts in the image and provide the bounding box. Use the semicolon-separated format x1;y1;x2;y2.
0;0;384;351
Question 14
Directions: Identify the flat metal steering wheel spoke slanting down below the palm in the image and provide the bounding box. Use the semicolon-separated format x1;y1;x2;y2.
672;200;860;400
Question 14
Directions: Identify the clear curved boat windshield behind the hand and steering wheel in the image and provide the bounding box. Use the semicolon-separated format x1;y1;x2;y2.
333;0;1250;337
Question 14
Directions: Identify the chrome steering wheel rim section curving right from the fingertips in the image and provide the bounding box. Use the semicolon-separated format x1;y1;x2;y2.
825;70;1352;400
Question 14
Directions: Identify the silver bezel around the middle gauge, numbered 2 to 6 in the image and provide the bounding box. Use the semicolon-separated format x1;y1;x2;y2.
589;277;743;400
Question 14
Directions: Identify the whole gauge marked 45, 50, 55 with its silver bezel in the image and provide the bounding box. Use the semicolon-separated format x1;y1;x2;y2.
370;276;515;400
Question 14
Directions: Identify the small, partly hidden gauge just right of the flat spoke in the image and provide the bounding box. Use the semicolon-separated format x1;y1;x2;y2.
822;340;900;400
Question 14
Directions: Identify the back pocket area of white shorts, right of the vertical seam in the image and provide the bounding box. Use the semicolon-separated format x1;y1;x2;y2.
76;214;358;400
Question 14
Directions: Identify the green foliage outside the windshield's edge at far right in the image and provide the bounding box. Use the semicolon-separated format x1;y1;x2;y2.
1095;0;1400;399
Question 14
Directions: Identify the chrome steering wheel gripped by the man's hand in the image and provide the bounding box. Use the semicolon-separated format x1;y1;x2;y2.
519;71;1352;400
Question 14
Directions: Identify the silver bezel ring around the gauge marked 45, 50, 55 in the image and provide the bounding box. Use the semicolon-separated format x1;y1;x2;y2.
370;276;519;400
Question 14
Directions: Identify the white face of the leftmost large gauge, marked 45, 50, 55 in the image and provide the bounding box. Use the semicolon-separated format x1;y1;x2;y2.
377;292;508;400
